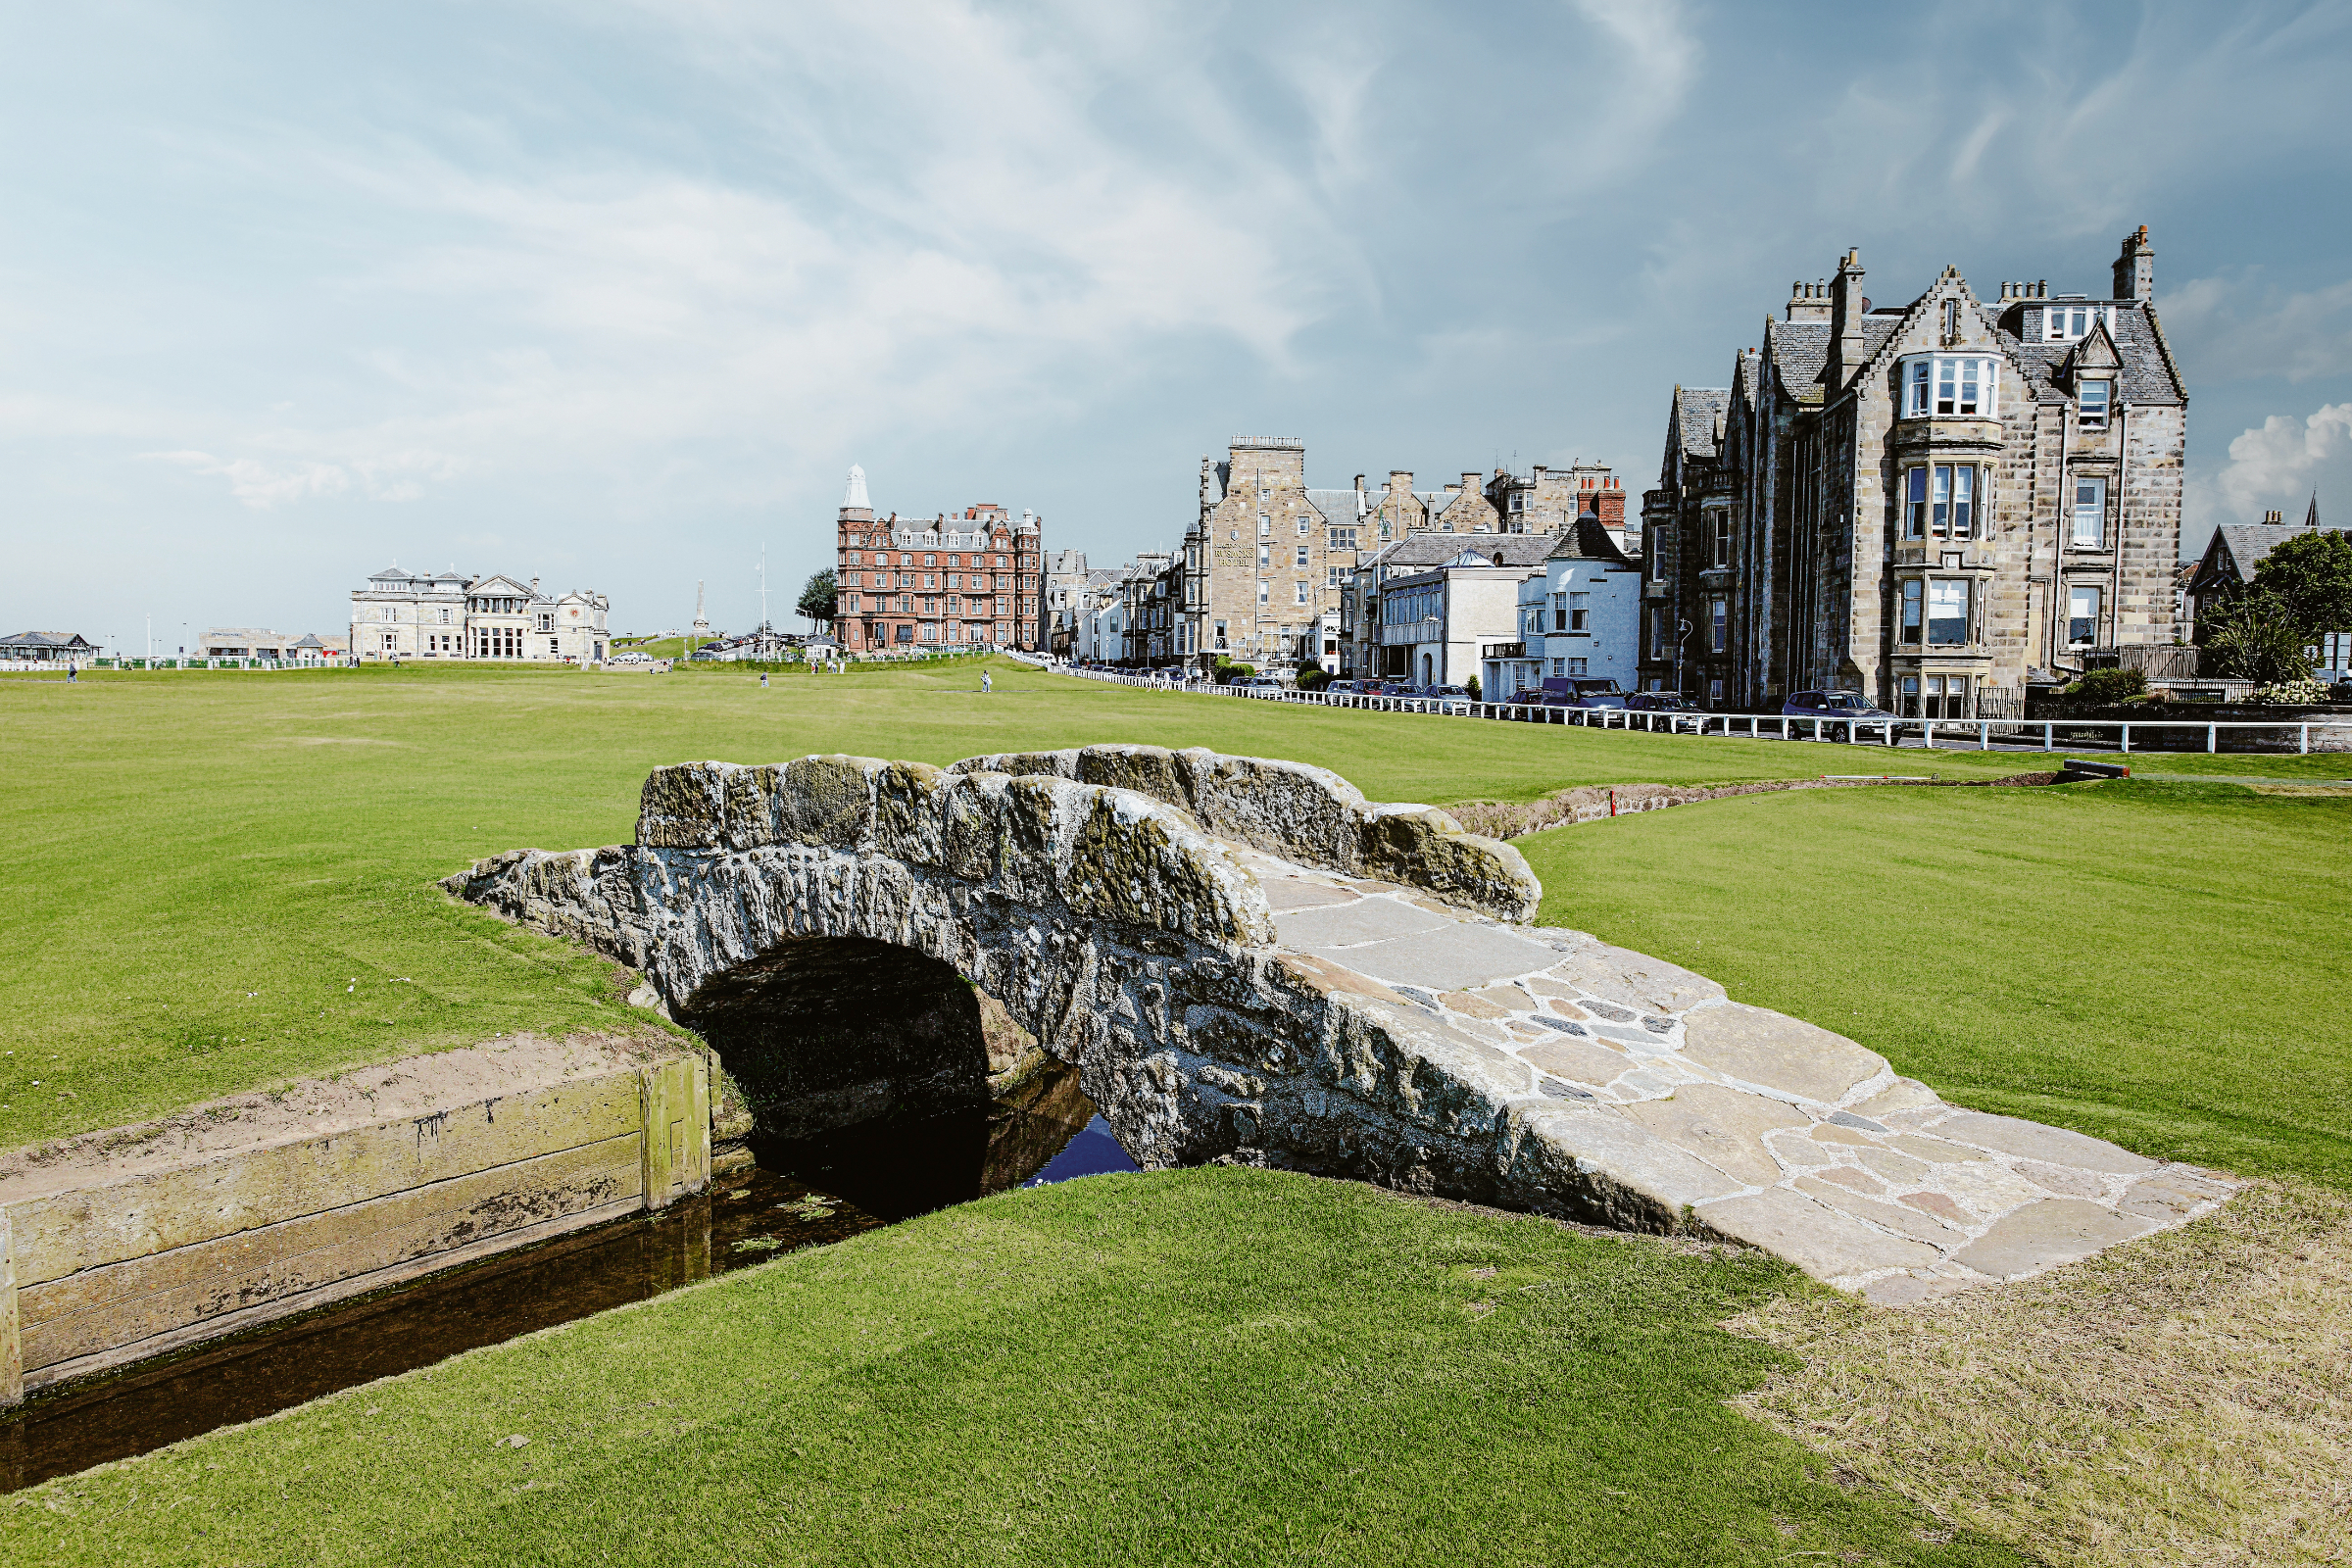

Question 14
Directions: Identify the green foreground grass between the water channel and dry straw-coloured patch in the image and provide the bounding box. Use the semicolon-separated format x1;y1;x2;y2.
0;1168;2021;1568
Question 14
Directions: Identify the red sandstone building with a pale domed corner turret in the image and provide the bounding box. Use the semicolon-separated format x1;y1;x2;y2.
833;467;1047;654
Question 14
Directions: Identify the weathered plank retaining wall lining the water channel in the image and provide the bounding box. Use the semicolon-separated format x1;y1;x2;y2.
0;1054;710;1405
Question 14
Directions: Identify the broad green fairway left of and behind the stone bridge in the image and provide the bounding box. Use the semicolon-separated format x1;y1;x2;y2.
0;661;2345;1148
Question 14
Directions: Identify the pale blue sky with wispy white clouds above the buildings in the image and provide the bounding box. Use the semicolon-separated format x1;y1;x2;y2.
0;0;2352;654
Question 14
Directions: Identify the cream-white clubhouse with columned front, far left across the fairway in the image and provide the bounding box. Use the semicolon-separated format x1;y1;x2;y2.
351;562;612;662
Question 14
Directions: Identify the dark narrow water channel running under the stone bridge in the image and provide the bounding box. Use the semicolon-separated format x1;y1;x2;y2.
0;1074;1136;1491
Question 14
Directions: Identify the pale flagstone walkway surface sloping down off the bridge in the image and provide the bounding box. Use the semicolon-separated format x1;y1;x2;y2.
1240;854;2236;1304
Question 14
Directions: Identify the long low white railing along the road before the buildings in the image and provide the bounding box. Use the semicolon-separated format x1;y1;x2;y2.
1047;665;2352;753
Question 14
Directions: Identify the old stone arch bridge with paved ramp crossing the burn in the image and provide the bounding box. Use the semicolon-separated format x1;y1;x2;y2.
447;745;2230;1302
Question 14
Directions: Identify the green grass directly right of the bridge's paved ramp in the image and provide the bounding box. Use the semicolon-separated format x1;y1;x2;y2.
1519;783;2352;1187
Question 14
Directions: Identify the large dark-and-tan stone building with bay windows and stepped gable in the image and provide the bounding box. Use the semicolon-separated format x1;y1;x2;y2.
1642;228;2187;717
